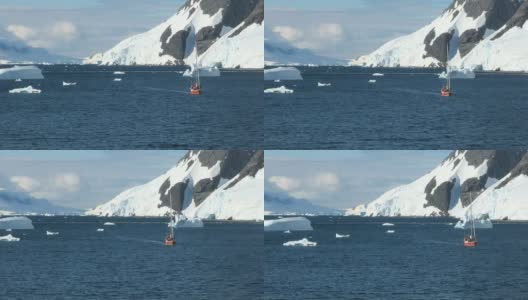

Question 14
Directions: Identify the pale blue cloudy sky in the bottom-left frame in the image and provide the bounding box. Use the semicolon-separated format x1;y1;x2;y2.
0;150;186;209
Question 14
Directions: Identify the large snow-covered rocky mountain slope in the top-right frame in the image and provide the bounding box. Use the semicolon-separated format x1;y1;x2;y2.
350;0;528;71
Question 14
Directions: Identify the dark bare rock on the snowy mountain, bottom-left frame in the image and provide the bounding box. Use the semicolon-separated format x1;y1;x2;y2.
159;150;264;211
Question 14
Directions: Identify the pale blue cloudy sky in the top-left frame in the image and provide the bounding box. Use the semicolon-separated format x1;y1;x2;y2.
0;0;185;58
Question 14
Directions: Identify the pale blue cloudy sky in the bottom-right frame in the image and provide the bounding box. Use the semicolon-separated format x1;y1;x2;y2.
265;150;450;209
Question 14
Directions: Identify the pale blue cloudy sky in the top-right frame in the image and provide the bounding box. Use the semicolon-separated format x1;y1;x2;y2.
265;0;452;59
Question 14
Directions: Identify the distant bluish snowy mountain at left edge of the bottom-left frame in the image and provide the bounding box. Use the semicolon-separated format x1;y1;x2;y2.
0;188;81;215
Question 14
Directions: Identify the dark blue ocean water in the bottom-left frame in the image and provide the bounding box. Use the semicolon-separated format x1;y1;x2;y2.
0;217;263;300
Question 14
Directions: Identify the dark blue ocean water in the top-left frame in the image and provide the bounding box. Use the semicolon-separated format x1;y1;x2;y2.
0;66;264;149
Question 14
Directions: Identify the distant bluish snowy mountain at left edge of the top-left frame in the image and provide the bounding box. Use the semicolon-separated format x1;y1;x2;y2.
0;36;79;64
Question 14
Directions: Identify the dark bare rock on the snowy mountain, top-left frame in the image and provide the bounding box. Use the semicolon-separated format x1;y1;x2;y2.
160;0;264;64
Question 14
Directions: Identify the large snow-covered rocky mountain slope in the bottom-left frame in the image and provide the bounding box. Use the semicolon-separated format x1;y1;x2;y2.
87;150;264;220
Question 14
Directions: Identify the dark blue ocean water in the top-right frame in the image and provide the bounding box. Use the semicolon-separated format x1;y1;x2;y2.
264;67;528;149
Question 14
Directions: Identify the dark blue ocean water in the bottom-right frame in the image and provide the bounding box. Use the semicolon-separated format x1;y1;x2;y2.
264;217;528;299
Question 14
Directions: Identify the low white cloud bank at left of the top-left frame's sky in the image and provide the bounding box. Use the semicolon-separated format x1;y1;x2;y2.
6;21;79;48
